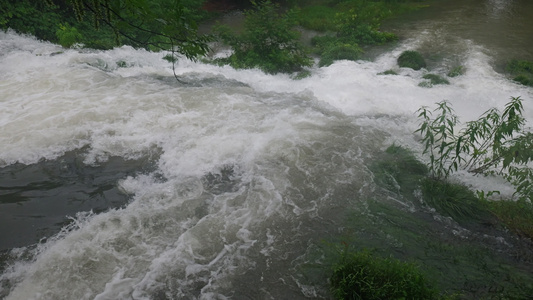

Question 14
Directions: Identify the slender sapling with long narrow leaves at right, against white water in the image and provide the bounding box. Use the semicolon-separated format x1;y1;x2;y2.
416;97;533;199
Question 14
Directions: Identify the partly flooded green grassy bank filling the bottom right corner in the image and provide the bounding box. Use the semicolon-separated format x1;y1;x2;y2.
326;145;533;299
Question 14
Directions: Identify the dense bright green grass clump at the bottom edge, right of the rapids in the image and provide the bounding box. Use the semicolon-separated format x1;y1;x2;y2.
330;250;438;300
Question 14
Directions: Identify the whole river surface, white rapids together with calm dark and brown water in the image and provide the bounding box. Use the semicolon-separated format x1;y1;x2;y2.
0;0;533;300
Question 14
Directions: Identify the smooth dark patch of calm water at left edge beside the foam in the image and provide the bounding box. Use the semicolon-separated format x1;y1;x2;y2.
0;151;153;251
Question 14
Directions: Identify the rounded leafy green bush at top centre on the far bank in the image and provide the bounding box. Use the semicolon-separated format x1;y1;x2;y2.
217;1;313;73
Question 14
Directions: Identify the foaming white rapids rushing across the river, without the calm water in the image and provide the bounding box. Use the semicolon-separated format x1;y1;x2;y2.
0;27;533;300
